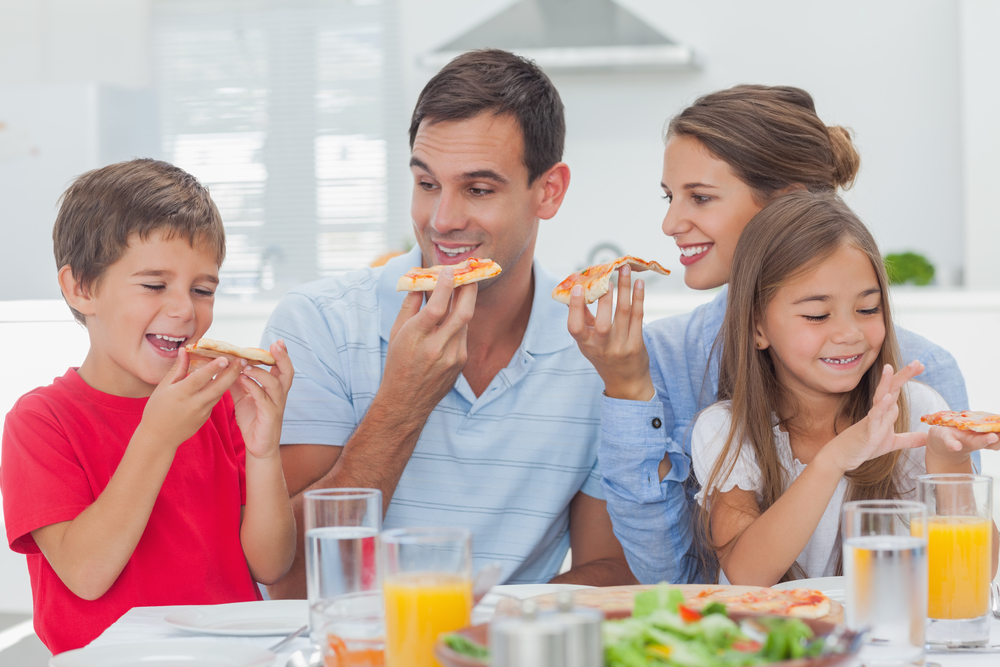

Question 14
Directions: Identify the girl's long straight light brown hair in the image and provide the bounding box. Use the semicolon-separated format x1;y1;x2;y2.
699;191;909;581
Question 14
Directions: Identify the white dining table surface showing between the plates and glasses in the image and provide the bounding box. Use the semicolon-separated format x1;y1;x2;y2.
76;584;1000;667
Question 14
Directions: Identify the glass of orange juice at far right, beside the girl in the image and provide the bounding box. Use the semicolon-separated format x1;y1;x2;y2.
918;475;993;646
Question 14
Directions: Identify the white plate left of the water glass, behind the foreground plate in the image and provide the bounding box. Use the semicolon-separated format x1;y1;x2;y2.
164;600;309;637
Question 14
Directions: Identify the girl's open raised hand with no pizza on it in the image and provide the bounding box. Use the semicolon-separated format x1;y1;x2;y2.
824;361;927;472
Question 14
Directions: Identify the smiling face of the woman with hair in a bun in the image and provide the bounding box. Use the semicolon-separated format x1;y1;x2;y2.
660;136;763;289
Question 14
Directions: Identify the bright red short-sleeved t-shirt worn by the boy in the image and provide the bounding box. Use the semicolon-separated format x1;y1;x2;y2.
0;369;260;653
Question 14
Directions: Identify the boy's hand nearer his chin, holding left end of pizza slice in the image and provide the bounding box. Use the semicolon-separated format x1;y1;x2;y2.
137;348;240;449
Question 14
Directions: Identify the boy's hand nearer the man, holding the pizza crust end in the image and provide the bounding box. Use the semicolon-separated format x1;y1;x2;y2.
230;340;295;458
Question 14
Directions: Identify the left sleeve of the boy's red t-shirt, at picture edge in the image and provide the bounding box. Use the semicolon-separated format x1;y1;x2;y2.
0;399;96;554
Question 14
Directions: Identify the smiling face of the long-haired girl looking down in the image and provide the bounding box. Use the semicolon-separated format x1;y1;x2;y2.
756;245;885;401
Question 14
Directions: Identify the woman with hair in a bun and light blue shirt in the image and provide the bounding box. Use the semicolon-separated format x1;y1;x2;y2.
568;85;979;583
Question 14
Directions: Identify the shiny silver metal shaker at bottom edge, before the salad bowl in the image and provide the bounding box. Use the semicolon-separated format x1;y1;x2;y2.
490;601;566;667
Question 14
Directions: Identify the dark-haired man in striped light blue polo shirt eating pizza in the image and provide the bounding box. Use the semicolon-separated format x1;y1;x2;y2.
264;50;635;597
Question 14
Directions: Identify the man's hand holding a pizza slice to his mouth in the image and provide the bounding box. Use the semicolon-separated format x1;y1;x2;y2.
376;267;478;418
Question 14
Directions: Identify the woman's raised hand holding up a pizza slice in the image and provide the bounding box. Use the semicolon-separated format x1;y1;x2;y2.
567;264;656;401
